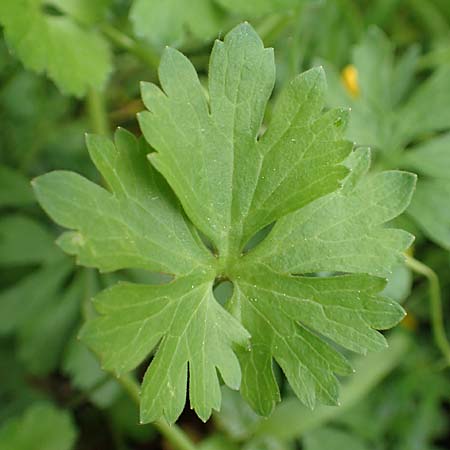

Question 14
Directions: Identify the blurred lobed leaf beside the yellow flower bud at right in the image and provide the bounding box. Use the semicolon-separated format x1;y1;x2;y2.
327;28;450;249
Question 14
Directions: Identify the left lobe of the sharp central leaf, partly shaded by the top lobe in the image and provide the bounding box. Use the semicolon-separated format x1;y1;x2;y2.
34;129;210;274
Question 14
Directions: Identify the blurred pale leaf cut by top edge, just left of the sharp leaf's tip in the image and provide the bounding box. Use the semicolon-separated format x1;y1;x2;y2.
130;0;221;46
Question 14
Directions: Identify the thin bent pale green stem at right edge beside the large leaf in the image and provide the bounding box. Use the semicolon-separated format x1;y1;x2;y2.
406;255;450;366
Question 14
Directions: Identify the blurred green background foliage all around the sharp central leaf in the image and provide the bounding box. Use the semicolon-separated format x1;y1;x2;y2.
0;0;450;450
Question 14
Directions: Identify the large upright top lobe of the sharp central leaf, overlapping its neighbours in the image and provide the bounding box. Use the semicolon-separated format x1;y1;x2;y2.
139;24;351;254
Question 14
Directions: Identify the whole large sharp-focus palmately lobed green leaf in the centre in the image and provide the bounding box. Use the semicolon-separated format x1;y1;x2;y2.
34;24;415;422
